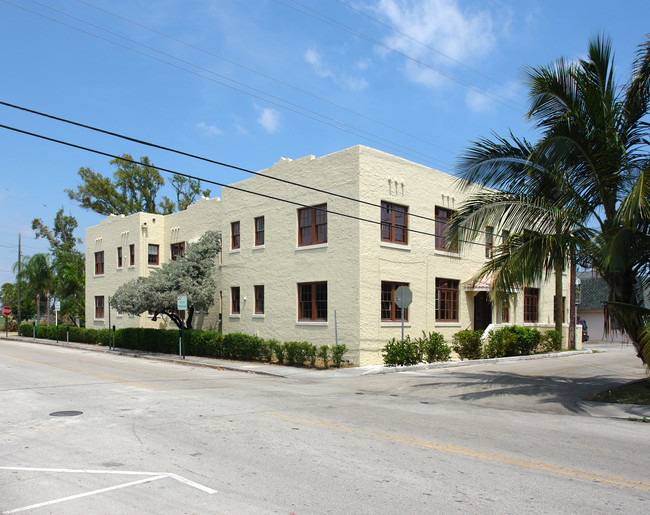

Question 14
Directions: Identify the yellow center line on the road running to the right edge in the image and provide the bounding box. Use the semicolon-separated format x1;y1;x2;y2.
267;413;650;491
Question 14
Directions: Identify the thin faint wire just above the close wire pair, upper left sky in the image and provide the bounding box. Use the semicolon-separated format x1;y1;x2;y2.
72;0;450;157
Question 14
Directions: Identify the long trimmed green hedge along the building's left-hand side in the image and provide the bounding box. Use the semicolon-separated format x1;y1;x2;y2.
19;324;347;368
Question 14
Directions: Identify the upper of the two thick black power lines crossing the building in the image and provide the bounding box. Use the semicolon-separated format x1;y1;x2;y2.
0;100;492;240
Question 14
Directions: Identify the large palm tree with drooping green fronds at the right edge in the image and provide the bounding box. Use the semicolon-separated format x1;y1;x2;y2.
450;33;650;359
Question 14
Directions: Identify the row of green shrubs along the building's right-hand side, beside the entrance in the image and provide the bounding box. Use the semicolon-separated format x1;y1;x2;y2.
382;326;562;366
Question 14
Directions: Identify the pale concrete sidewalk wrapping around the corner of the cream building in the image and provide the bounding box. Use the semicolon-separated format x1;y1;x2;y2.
0;333;650;421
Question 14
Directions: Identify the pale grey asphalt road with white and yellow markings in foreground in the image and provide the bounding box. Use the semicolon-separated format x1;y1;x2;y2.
0;340;650;514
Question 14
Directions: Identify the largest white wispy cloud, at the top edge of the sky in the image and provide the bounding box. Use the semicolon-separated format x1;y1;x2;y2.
375;0;496;86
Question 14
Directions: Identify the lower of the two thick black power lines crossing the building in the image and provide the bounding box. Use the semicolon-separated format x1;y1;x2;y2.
0;124;486;247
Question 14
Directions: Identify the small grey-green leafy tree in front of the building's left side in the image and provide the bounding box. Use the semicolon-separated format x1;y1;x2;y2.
111;231;221;329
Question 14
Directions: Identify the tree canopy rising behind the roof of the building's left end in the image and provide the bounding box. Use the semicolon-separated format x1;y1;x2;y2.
65;154;210;216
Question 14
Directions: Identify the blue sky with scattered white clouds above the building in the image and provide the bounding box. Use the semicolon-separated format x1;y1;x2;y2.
0;0;650;284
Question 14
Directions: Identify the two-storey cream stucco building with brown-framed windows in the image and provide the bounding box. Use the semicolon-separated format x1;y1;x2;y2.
86;146;568;365
